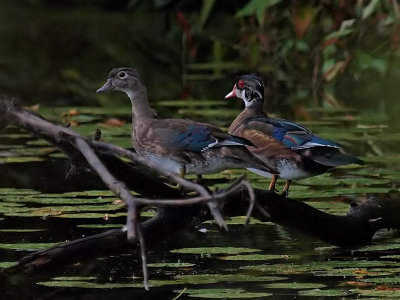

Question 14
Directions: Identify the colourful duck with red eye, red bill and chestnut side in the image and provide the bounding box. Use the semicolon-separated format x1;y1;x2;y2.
225;75;364;193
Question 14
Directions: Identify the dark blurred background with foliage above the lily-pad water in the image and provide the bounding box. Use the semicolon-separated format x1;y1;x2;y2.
0;0;400;123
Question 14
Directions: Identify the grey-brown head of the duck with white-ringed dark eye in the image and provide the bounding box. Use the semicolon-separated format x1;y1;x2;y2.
97;67;145;99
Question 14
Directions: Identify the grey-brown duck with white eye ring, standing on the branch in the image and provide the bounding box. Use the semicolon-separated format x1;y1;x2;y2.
97;68;277;184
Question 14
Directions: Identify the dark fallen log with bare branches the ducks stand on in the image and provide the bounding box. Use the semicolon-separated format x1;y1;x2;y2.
0;100;400;282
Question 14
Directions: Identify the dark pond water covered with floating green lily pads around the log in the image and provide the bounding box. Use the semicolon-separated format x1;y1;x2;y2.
0;101;400;299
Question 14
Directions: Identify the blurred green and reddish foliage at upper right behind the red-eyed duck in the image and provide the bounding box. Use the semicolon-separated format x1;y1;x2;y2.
180;0;400;117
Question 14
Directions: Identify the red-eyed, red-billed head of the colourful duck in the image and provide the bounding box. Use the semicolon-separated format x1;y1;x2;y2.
225;75;264;107
